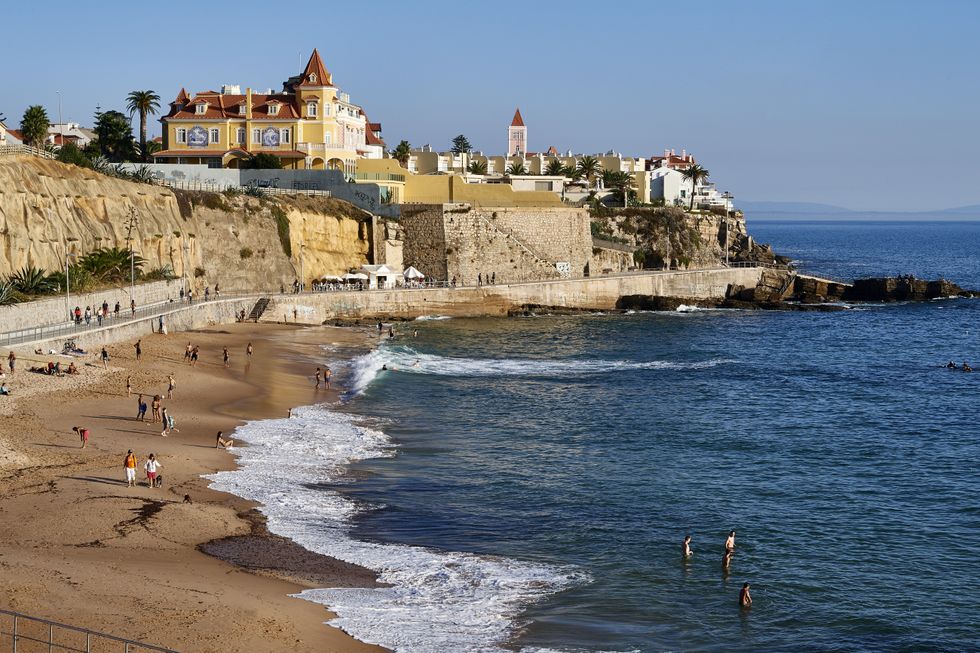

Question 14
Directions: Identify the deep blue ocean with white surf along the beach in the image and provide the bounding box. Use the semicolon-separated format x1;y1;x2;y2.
214;221;980;653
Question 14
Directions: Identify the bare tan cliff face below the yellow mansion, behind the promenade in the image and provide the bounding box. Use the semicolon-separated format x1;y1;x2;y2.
0;157;372;290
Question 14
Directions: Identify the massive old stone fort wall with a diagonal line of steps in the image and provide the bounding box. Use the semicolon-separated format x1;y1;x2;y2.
401;203;592;284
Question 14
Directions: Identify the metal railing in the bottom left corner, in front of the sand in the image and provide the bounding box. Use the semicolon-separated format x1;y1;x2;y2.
0;610;177;653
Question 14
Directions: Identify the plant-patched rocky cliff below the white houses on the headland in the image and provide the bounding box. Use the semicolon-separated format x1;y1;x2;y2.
592;208;787;269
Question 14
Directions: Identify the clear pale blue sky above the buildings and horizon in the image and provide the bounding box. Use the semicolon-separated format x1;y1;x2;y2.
0;0;980;211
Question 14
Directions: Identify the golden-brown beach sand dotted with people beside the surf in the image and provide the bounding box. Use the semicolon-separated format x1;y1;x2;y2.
0;324;383;653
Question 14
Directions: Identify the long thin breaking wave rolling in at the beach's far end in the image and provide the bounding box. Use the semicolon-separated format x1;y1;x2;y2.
350;345;736;395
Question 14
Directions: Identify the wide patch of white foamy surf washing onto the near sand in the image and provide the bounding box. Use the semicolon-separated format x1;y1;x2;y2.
207;406;590;653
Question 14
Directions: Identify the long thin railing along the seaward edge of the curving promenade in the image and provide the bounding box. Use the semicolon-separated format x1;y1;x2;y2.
0;261;786;347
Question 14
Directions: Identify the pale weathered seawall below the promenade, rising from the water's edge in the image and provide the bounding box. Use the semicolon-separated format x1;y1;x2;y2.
262;268;764;323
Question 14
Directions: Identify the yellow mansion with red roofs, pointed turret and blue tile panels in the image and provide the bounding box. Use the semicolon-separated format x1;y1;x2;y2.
153;50;384;175
